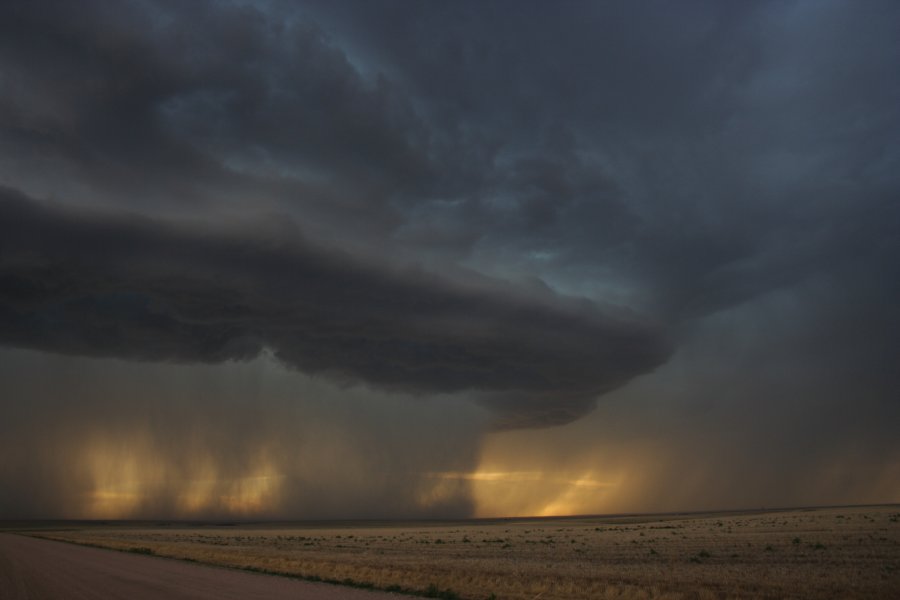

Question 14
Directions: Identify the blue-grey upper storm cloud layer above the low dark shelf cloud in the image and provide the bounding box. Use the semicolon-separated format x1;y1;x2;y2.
0;2;900;404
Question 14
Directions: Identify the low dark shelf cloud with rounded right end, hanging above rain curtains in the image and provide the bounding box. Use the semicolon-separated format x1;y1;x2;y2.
0;189;669;427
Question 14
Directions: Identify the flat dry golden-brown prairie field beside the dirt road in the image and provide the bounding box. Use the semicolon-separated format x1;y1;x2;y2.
14;505;900;600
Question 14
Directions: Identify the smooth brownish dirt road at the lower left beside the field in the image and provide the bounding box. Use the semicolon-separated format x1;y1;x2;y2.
0;534;404;600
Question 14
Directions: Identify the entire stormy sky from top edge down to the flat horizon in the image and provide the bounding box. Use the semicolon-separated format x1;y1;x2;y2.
0;0;900;520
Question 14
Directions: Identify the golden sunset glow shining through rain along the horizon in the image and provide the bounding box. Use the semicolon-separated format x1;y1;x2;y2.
54;430;900;519
